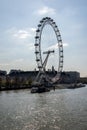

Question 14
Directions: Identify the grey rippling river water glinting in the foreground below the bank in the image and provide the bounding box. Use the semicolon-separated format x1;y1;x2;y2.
0;86;87;130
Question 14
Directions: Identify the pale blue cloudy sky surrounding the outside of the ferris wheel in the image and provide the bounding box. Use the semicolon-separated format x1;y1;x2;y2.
0;0;87;76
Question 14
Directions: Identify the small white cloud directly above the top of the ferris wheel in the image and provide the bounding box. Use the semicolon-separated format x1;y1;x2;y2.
37;6;56;15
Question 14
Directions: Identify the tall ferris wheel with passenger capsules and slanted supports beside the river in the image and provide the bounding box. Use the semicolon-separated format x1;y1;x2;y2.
35;17;63;84
